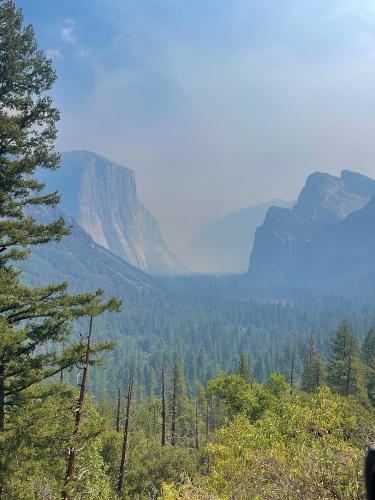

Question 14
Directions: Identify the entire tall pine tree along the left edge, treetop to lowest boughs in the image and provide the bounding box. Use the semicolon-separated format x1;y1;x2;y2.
0;0;119;436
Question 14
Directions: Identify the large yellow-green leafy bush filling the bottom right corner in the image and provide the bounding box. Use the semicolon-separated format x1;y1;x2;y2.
164;387;375;499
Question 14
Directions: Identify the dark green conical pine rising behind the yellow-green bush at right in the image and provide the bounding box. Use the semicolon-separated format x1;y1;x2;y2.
328;322;366;399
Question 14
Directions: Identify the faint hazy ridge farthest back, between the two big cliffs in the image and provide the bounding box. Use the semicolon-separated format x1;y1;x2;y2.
182;199;292;273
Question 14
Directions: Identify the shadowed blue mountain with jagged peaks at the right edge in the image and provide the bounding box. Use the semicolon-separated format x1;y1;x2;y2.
248;170;375;286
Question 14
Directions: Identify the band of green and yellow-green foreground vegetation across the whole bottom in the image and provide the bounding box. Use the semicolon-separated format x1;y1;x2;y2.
1;354;375;499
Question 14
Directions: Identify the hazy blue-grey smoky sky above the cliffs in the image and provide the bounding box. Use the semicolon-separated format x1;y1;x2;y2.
16;0;375;249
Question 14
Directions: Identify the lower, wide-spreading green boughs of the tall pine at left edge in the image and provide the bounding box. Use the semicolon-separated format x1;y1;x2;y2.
0;271;119;431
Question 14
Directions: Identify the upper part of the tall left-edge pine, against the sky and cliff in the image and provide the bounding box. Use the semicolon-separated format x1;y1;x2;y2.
0;0;68;269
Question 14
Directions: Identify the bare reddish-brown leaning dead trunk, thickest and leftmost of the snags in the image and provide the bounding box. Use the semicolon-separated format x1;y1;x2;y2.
63;316;92;500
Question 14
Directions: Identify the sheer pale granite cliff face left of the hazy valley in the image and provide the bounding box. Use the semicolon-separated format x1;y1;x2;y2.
42;151;181;274
